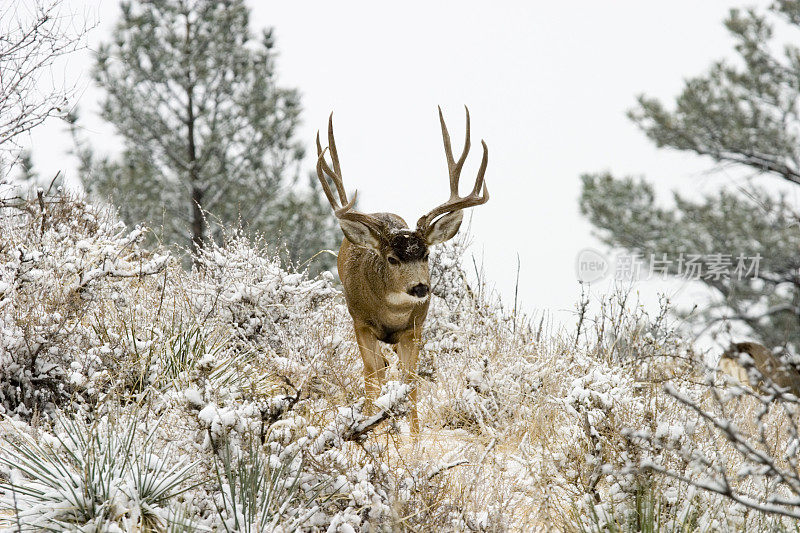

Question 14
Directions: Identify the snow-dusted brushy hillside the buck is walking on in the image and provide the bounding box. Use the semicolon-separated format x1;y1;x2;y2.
0;196;800;532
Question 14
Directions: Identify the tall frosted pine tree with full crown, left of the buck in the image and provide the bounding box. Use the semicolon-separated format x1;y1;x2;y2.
82;0;335;268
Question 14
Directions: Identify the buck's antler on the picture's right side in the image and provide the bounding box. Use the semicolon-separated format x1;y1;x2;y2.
417;106;489;234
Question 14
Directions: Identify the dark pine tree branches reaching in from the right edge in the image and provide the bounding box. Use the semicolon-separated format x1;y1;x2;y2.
581;1;800;354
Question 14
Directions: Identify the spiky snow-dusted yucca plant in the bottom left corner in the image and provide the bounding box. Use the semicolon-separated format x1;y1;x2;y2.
0;415;196;531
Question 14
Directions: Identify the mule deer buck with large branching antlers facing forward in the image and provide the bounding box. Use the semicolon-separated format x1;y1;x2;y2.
317;108;489;434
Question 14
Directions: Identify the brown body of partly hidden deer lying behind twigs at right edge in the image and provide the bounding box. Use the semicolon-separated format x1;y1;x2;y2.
719;342;800;397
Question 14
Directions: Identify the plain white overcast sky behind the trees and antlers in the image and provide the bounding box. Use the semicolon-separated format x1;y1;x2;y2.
21;0;780;332
